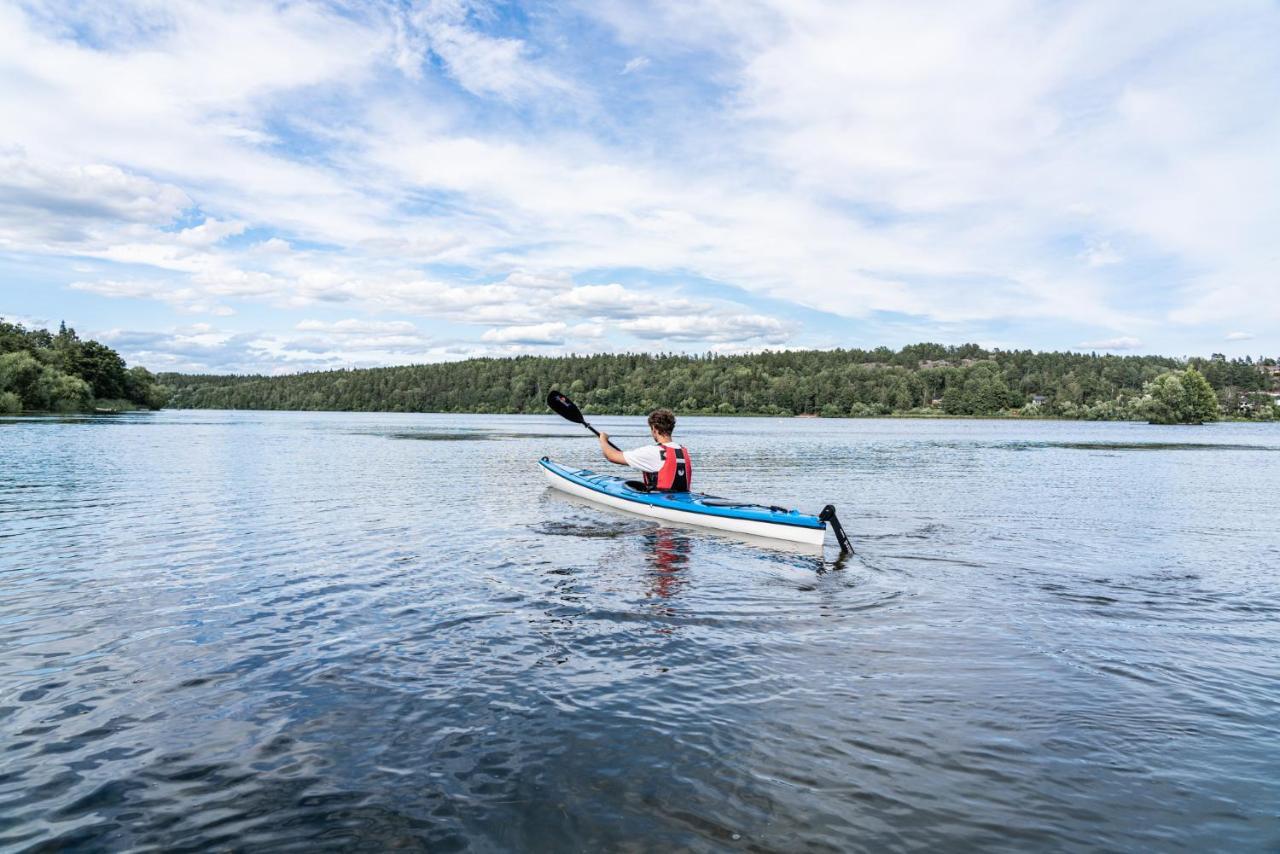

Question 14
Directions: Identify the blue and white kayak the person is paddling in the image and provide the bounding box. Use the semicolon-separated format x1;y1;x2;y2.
539;457;827;548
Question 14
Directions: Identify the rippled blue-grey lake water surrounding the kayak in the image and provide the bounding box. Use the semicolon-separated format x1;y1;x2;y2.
0;412;1280;851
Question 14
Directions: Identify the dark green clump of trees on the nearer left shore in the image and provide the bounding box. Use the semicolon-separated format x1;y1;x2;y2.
0;319;168;414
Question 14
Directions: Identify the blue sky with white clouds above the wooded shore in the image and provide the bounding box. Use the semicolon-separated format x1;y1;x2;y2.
0;0;1280;374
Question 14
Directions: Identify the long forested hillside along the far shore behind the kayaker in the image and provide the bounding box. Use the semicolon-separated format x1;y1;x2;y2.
161;344;1275;419
